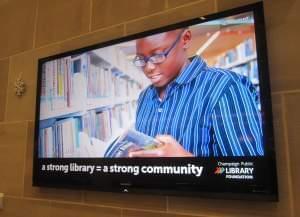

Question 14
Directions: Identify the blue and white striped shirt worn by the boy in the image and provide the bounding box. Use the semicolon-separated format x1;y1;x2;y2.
136;58;264;157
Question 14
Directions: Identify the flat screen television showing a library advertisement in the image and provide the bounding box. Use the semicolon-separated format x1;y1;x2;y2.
33;3;277;200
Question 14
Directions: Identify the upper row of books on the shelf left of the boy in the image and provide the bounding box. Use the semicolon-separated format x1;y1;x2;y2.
41;53;141;116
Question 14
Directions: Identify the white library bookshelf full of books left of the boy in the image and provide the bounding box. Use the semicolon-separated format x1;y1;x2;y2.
39;46;148;158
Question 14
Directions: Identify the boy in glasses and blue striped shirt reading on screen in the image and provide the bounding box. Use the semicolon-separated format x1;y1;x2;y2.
129;28;264;157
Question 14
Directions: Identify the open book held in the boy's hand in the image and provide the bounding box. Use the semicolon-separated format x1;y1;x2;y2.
104;129;162;158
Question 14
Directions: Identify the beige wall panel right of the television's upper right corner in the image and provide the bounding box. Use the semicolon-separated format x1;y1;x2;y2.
264;0;300;92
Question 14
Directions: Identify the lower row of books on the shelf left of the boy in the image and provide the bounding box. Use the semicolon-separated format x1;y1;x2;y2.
39;102;136;158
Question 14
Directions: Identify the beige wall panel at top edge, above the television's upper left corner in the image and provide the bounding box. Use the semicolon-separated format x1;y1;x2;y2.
35;0;90;47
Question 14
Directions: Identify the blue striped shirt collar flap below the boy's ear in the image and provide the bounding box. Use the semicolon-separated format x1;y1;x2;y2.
175;56;206;85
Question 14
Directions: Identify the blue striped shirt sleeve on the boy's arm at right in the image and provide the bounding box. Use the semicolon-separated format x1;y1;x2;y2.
212;83;264;156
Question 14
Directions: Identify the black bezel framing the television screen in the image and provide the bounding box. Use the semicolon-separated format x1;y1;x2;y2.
32;2;278;201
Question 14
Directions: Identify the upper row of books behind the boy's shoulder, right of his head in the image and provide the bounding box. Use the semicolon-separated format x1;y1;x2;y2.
215;38;256;68
